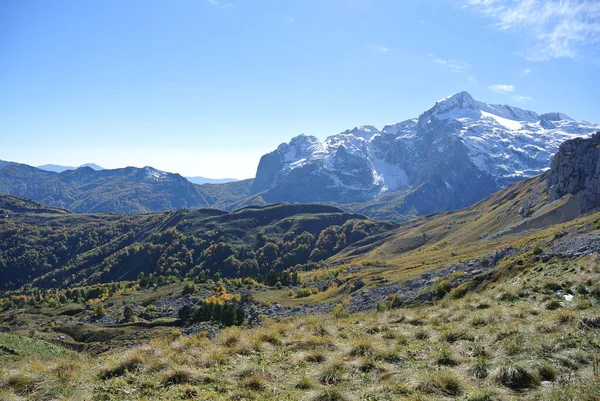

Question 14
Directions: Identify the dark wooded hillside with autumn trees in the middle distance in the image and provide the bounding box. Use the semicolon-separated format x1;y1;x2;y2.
0;200;395;289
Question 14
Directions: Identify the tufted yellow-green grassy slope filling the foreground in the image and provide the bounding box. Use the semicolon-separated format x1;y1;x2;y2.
0;255;600;401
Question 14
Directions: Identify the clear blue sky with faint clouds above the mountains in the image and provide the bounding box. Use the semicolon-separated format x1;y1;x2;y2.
0;0;600;178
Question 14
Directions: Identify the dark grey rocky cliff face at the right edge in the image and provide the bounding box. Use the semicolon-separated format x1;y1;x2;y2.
548;132;600;213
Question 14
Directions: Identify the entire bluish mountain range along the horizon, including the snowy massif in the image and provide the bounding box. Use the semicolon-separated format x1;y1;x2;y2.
0;92;600;220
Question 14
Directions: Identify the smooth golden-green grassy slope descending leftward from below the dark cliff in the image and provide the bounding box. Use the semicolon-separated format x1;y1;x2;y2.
256;175;580;305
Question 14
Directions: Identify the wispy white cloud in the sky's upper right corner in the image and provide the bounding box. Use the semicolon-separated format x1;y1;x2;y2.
463;0;600;61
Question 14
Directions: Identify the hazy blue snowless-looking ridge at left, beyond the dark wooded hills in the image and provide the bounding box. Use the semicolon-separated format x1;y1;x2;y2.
0;163;209;213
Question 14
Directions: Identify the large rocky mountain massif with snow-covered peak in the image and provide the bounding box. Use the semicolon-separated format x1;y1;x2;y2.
252;92;600;213
